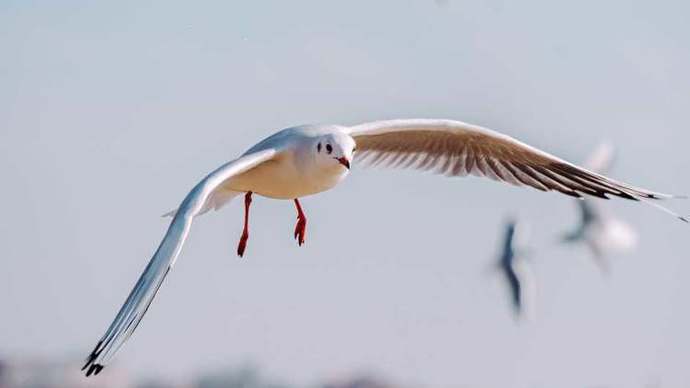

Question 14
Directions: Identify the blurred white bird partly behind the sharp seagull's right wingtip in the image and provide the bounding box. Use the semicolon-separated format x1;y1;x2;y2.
563;144;637;274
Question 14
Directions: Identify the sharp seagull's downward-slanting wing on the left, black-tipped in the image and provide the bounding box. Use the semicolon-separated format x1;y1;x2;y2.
82;149;276;376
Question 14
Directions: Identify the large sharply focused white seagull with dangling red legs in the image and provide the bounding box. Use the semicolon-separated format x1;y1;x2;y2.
82;119;687;376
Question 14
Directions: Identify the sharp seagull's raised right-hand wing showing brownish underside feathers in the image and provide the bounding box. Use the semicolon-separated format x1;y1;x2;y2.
346;119;687;222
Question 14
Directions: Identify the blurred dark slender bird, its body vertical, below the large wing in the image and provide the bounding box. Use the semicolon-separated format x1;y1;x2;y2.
496;220;535;316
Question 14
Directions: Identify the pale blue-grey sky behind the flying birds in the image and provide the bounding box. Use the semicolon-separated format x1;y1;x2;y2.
0;0;690;388
